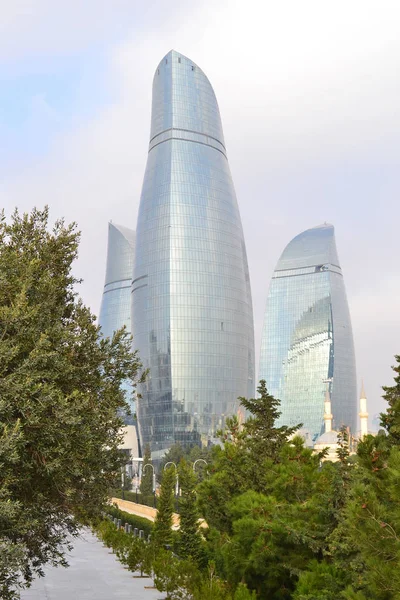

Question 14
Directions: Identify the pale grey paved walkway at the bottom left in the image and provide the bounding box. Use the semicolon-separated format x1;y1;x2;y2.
21;529;165;600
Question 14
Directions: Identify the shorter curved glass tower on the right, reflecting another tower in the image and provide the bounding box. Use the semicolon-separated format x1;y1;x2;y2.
259;224;357;440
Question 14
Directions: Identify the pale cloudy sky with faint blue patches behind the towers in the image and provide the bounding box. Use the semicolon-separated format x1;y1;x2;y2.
0;0;400;416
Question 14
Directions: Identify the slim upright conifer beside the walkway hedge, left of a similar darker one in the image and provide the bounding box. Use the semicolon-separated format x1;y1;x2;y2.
152;466;176;547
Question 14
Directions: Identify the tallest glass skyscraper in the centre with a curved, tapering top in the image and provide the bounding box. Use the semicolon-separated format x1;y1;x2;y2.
132;51;254;458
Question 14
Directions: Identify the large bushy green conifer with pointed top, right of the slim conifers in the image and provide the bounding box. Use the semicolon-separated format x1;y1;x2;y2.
199;394;342;600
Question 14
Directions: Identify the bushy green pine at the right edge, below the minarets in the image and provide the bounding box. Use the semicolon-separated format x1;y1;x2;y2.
294;410;400;600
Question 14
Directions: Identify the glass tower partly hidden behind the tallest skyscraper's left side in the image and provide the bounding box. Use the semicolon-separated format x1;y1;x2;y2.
99;223;135;424
